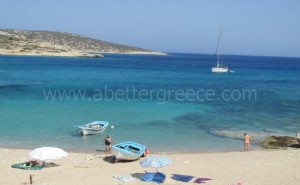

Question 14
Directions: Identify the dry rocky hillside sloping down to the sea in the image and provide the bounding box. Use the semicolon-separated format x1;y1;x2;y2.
0;29;162;56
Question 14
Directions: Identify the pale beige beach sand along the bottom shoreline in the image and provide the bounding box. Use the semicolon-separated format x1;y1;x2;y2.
0;148;300;185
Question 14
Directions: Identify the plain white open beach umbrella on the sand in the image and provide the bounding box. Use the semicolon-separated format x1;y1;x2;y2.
29;147;68;161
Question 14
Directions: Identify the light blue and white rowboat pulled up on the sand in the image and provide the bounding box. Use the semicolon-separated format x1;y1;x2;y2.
112;141;146;162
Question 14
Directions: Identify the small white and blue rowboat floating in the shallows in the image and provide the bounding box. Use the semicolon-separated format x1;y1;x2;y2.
78;121;109;135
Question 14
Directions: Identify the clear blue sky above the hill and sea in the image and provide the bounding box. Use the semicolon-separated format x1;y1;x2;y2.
0;0;300;57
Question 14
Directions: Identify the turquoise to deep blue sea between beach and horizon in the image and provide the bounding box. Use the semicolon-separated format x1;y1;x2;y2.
0;53;300;152
